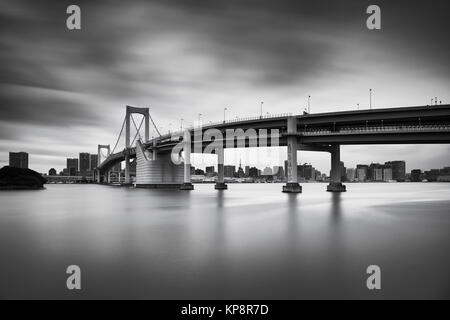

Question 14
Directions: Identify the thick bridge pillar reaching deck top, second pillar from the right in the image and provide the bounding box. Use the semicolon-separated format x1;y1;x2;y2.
283;117;302;193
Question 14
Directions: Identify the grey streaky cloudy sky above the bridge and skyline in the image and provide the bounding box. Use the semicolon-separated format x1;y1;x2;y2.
0;0;450;172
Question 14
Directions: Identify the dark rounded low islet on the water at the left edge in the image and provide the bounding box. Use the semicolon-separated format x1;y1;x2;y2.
0;166;47;190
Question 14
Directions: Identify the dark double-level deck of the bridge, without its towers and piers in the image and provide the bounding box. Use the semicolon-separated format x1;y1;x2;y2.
99;104;450;171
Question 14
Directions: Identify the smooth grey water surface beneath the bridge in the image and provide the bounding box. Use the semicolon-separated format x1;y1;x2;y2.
0;183;450;299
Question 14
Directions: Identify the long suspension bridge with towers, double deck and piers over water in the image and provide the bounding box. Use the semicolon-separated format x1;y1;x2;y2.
95;104;450;193
